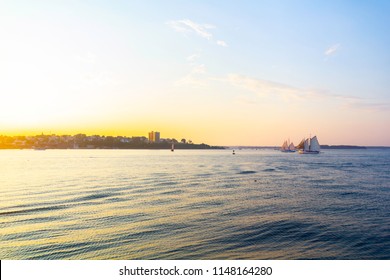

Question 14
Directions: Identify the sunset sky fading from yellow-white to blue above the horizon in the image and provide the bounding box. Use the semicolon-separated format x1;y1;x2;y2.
0;0;390;146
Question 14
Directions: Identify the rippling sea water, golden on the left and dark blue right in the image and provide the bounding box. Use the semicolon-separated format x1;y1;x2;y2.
0;149;390;259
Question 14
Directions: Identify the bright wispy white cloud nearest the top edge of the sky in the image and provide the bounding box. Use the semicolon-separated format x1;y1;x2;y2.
167;19;227;47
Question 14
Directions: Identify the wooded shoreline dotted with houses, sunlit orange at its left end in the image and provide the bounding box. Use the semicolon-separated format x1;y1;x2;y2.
0;134;224;149
